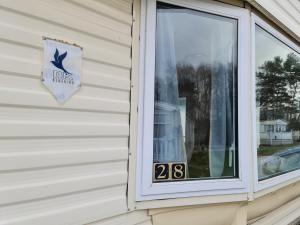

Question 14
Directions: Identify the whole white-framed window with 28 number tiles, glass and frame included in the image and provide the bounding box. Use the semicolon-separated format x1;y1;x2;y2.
137;1;251;200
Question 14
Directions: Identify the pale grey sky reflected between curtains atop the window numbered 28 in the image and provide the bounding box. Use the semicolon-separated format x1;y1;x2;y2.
164;9;237;68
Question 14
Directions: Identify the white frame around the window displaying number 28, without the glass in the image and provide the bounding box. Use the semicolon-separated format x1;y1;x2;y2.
136;0;252;201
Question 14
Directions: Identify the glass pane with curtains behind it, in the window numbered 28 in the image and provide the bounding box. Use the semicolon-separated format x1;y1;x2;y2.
153;3;238;181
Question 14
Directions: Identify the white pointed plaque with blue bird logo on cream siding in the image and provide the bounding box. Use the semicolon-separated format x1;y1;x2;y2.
42;39;82;103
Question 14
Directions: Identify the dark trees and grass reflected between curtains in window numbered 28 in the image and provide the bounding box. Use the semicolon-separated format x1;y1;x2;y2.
177;63;212;177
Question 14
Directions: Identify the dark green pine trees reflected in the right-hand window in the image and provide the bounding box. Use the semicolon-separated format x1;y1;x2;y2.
256;53;300;123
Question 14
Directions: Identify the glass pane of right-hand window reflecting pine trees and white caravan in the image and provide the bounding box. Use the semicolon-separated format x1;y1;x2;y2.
255;26;300;180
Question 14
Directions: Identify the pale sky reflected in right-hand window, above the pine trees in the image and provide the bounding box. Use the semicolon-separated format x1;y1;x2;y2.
255;25;297;69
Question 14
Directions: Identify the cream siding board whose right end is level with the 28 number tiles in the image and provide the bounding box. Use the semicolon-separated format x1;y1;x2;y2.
0;163;127;205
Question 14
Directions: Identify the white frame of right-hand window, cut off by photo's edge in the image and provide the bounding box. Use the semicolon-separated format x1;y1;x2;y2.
251;13;300;192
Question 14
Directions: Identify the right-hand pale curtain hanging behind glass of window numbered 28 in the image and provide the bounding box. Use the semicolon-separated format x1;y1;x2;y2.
209;24;236;177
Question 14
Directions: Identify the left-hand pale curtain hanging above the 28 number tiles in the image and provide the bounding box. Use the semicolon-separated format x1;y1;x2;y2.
153;9;186;163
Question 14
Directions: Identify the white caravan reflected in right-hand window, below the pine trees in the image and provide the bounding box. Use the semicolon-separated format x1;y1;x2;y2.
260;120;293;145
